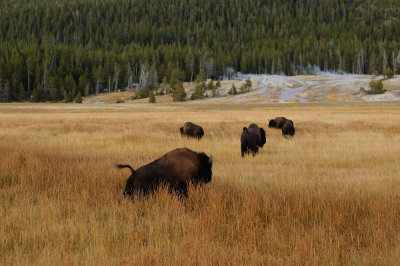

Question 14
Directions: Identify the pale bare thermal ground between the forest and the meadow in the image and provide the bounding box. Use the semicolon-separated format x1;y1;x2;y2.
84;74;400;104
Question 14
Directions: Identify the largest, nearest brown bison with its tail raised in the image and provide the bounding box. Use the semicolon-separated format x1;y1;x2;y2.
117;148;212;196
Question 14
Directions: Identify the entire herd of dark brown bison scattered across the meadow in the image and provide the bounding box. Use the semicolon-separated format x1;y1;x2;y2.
117;117;295;197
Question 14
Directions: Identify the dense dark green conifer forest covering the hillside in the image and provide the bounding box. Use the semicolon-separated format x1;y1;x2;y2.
0;0;400;102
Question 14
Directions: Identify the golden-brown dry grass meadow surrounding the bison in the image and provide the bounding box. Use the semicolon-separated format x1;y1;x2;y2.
0;102;400;265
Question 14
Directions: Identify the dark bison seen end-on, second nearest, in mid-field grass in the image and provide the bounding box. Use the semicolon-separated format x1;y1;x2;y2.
240;124;266;157
